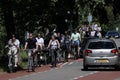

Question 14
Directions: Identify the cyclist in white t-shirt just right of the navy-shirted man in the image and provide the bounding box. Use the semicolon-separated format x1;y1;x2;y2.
36;33;44;66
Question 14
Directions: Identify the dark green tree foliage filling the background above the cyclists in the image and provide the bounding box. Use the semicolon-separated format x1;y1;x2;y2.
0;0;120;51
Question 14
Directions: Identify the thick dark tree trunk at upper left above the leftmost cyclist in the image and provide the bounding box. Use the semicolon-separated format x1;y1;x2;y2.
2;0;15;38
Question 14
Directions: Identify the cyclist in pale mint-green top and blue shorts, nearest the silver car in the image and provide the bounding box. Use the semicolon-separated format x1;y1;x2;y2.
71;30;80;58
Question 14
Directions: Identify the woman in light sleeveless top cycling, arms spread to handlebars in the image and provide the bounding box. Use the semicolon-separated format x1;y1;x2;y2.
47;36;60;67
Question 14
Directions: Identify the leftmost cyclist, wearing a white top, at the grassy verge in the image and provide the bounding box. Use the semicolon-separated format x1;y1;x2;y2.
8;35;20;67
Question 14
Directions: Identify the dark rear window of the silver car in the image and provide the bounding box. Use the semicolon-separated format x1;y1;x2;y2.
88;42;115;49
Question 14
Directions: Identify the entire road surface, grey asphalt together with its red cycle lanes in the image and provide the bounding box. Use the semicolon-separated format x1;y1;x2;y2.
0;59;120;80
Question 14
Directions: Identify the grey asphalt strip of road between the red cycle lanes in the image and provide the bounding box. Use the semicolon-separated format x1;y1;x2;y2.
12;61;97;80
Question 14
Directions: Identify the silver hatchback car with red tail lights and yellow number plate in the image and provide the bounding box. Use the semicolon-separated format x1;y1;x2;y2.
83;39;120;70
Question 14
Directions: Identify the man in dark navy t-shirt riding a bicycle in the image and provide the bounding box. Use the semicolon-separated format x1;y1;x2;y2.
23;33;38;67
